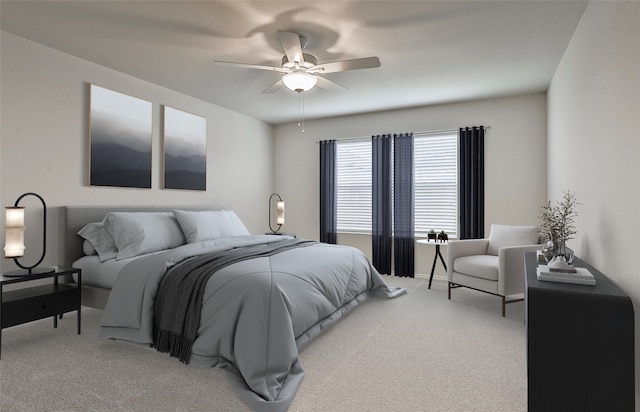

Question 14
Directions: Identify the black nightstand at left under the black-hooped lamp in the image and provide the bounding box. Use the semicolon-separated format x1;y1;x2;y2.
0;266;82;358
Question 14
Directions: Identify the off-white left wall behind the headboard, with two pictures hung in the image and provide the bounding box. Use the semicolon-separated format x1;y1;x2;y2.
0;32;273;270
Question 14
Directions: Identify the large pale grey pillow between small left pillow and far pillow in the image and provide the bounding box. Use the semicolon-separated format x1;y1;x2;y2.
104;212;185;260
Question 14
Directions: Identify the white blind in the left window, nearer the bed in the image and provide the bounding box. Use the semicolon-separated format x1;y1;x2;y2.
336;139;372;233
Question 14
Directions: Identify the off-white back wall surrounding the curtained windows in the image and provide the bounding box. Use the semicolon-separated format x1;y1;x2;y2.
274;93;547;275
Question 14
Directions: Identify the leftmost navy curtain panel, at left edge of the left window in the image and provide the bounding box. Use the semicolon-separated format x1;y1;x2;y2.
320;140;338;244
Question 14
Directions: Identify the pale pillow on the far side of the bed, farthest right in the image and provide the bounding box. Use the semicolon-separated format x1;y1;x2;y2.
173;210;249;243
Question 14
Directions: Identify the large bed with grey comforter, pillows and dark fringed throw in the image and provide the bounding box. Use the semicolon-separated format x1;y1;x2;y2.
63;206;405;411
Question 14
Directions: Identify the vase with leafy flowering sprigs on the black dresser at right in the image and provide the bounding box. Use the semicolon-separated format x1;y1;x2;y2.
540;191;580;263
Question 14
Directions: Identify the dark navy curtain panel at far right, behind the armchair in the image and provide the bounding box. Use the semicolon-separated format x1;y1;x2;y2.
458;126;484;239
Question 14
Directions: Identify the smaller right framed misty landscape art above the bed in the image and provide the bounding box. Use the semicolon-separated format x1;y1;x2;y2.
163;106;207;190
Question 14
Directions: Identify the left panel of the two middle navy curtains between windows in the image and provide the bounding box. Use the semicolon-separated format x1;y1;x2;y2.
371;135;392;275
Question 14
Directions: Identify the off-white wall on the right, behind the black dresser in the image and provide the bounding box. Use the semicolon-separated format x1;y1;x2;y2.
548;1;640;407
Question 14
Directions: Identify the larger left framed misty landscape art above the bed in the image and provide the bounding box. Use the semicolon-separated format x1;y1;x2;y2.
89;84;152;189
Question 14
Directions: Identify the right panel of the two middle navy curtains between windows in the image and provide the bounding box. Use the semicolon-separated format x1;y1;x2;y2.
393;133;415;277
